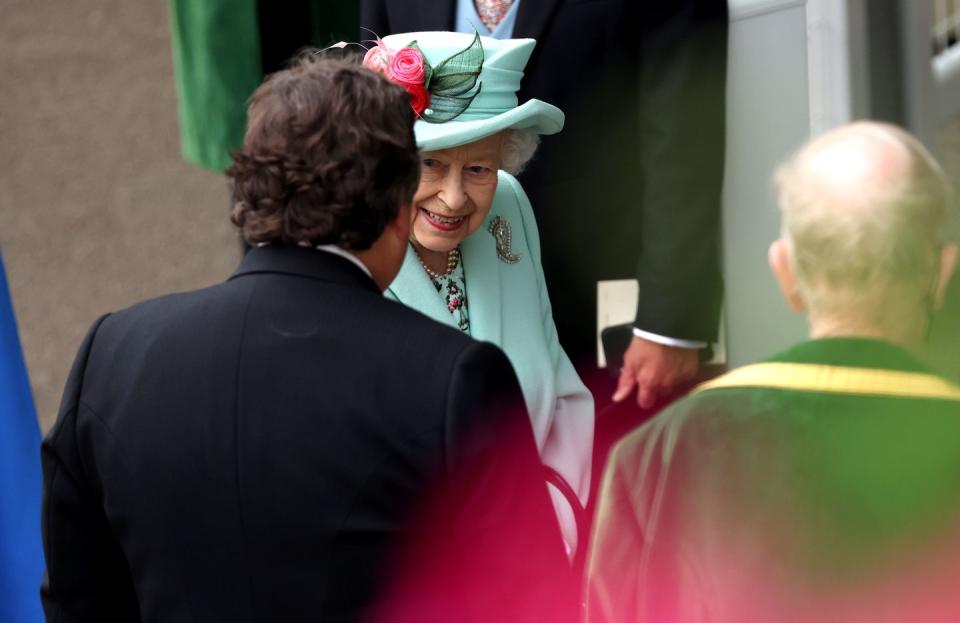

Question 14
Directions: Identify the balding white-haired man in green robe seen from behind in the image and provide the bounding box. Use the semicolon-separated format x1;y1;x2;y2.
587;122;960;623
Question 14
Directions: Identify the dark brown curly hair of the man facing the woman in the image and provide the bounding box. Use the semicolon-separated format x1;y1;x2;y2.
227;53;420;250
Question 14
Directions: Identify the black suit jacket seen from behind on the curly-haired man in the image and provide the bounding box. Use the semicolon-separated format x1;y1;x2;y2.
42;248;566;623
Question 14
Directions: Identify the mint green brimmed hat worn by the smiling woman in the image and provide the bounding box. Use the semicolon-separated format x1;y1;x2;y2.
382;32;564;151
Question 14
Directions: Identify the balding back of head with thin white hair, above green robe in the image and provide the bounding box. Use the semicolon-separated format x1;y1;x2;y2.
776;122;952;346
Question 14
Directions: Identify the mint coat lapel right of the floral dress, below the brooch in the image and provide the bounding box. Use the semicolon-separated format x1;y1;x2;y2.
464;217;506;344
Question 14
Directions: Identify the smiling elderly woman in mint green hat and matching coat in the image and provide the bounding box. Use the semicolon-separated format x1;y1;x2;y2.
364;32;594;553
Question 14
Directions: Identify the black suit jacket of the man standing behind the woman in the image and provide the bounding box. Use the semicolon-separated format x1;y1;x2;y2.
361;0;727;358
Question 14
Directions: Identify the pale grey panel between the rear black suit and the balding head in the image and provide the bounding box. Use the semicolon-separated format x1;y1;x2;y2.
723;0;810;365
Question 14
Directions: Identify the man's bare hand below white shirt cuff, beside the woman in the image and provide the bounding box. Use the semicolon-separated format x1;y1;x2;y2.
613;336;700;409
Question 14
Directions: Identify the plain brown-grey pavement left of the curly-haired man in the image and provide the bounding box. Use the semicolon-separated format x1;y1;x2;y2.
0;0;960;430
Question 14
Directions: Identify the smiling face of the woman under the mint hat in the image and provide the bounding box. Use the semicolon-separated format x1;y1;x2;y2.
412;134;503;253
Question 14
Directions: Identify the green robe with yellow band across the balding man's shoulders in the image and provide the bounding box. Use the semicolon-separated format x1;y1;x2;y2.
587;338;960;623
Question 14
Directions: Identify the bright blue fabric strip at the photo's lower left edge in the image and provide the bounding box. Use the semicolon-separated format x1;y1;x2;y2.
0;255;43;623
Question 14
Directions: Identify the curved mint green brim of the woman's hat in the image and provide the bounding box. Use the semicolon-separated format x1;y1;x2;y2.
413;99;564;151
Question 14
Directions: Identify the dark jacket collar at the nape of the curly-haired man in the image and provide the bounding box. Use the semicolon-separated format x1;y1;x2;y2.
230;246;380;293
